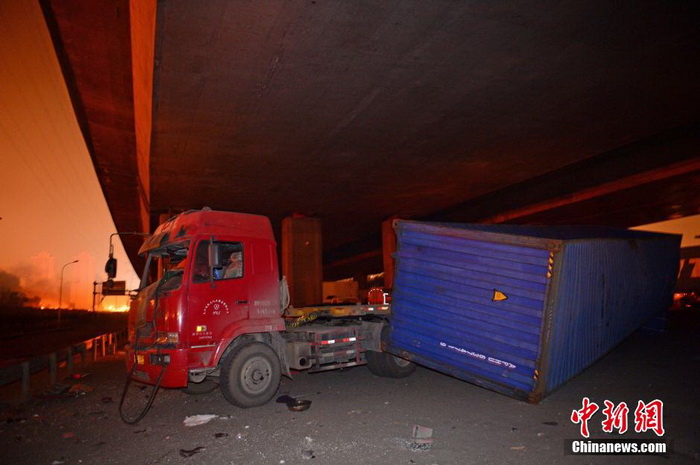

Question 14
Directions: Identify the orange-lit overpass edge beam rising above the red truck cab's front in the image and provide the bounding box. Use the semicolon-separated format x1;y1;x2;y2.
40;0;157;268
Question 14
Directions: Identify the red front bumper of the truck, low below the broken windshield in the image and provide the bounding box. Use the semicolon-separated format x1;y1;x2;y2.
126;347;188;388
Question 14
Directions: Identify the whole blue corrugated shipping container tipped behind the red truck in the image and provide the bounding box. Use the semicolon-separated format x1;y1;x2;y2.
387;220;680;403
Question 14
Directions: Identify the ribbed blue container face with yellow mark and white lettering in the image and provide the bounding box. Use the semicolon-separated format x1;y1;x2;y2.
388;223;551;398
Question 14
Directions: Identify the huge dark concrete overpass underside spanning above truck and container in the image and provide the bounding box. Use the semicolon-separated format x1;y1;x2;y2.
42;0;700;279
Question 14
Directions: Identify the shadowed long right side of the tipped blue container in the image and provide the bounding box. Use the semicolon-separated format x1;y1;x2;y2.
545;235;679;394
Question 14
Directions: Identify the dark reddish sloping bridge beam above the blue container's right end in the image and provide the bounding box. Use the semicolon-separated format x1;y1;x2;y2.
421;123;700;227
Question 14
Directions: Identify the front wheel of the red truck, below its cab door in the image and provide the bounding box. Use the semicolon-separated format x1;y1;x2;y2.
219;342;281;408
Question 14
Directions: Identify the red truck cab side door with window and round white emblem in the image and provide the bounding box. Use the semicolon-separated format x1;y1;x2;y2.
186;240;249;347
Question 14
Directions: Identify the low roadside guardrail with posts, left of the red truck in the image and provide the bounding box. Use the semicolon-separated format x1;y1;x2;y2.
2;330;126;401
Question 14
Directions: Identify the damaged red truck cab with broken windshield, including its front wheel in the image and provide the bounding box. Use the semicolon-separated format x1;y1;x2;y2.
127;209;288;407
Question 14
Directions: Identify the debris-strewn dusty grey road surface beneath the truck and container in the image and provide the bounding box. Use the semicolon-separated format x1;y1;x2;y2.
0;311;700;465
